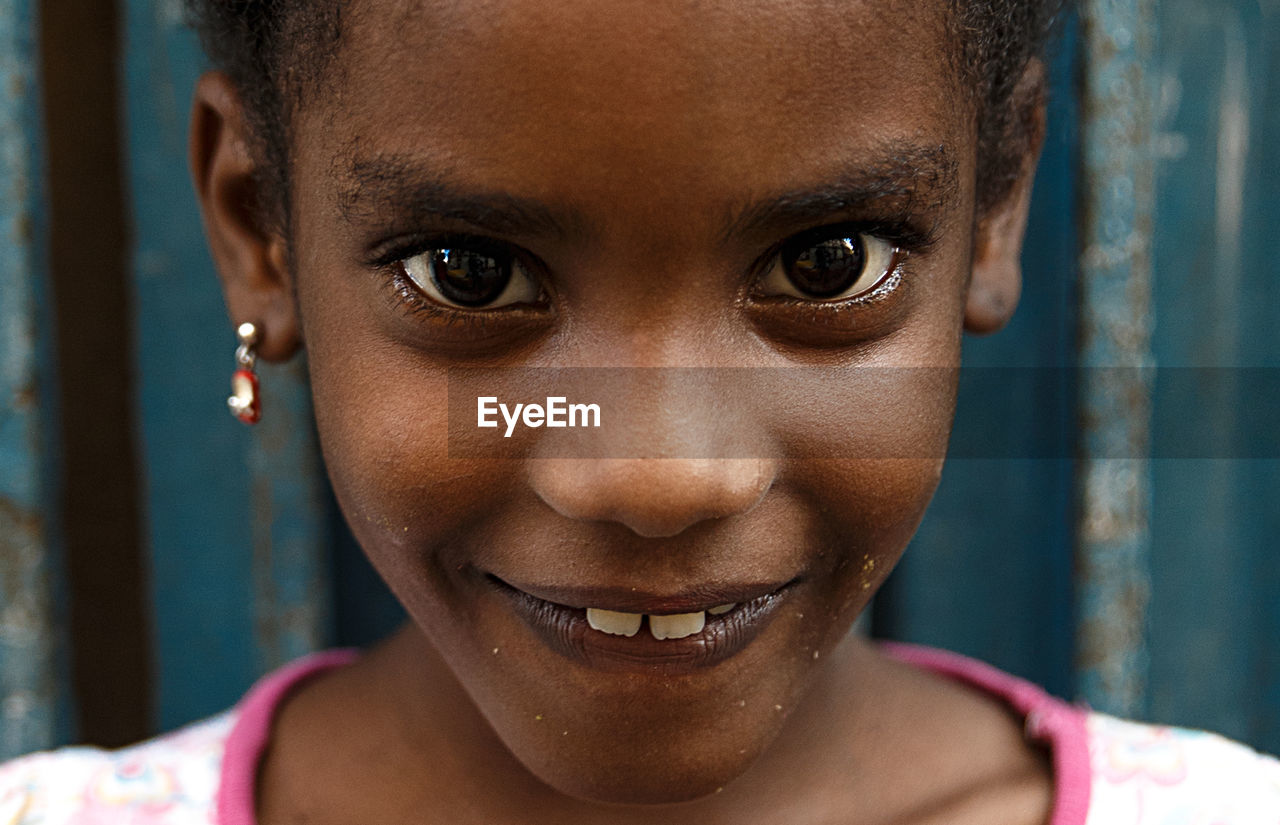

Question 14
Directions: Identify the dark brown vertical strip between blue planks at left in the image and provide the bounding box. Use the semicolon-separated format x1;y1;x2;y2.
40;0;150;746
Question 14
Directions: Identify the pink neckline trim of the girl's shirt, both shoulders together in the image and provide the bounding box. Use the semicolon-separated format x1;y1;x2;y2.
216;642;1092;825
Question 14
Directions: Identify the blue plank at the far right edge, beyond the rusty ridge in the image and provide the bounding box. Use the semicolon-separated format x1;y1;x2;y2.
1151;0;1280;752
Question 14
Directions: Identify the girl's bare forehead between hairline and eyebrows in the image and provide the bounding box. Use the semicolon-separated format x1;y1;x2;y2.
296;0;972;232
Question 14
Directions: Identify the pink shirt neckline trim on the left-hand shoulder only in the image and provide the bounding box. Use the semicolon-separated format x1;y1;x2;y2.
216;650;360;825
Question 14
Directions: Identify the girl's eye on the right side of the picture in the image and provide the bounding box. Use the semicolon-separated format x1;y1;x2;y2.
760;228;897;302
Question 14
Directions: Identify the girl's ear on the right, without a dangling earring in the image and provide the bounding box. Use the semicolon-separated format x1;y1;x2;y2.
964;60;1046;335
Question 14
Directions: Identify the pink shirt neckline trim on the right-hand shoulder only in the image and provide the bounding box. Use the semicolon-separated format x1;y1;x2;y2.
881;642;1093;825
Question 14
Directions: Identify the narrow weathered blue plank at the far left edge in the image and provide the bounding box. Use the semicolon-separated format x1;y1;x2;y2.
0;0;70;760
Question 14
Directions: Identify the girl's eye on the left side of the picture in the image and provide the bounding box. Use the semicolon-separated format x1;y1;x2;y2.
401;242;541;310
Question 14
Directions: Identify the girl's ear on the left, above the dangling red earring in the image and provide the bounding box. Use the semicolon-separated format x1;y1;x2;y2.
188;72;300;361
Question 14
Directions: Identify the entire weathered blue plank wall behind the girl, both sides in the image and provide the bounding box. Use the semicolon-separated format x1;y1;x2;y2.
0;0;1280;757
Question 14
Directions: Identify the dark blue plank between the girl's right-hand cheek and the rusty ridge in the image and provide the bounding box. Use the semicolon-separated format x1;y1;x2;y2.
873;9;1079;696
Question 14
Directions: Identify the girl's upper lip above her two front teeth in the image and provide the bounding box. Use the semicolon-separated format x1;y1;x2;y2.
493;576;795;615
